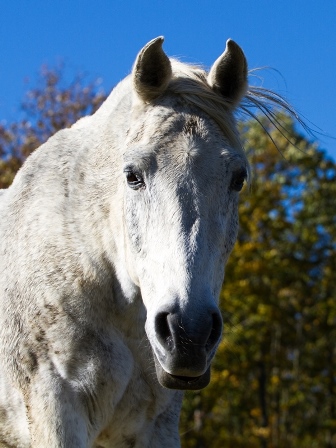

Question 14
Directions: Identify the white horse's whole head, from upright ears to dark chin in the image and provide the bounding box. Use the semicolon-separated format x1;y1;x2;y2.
117;38;248;389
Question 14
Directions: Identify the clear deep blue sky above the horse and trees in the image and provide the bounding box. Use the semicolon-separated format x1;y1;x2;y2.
0;0;336;160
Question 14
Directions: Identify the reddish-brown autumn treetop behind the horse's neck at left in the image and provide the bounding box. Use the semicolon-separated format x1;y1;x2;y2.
0;66;106;188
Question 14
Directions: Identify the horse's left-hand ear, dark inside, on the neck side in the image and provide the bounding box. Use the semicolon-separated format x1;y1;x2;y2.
132;36;172;101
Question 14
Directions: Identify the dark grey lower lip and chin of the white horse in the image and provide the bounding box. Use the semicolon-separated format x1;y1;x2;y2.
154;356;210;390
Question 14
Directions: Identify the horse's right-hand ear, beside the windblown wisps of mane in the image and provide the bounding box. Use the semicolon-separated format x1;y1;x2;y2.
208;39;247;108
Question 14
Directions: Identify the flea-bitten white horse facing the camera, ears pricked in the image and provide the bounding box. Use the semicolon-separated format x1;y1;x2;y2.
0;37;292;448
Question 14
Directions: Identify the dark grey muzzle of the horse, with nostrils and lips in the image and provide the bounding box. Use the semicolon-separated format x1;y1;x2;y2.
152;307;223;390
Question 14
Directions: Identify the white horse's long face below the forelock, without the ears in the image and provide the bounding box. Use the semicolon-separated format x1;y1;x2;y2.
123;98;247;389
